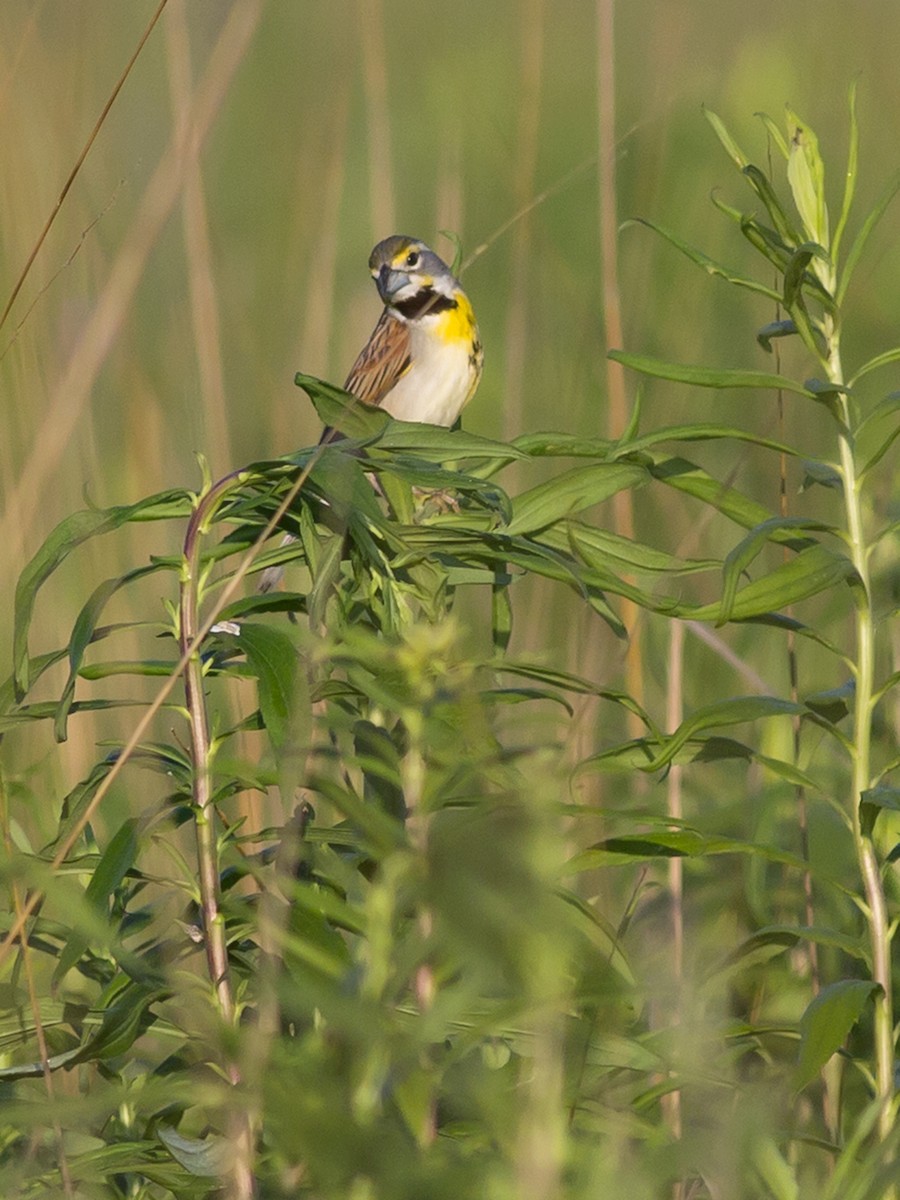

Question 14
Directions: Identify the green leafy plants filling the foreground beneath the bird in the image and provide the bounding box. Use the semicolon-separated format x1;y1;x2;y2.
0;103;898;1200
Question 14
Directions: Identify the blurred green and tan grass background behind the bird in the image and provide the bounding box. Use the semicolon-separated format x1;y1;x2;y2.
0;0;900;816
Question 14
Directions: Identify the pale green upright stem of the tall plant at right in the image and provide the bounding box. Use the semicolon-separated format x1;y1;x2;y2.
824;317;894;1140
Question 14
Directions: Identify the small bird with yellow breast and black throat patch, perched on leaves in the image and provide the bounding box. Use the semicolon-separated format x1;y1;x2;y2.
259;234;485;592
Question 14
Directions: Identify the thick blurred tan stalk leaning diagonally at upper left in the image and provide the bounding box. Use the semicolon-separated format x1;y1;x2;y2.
4;0;263;552
